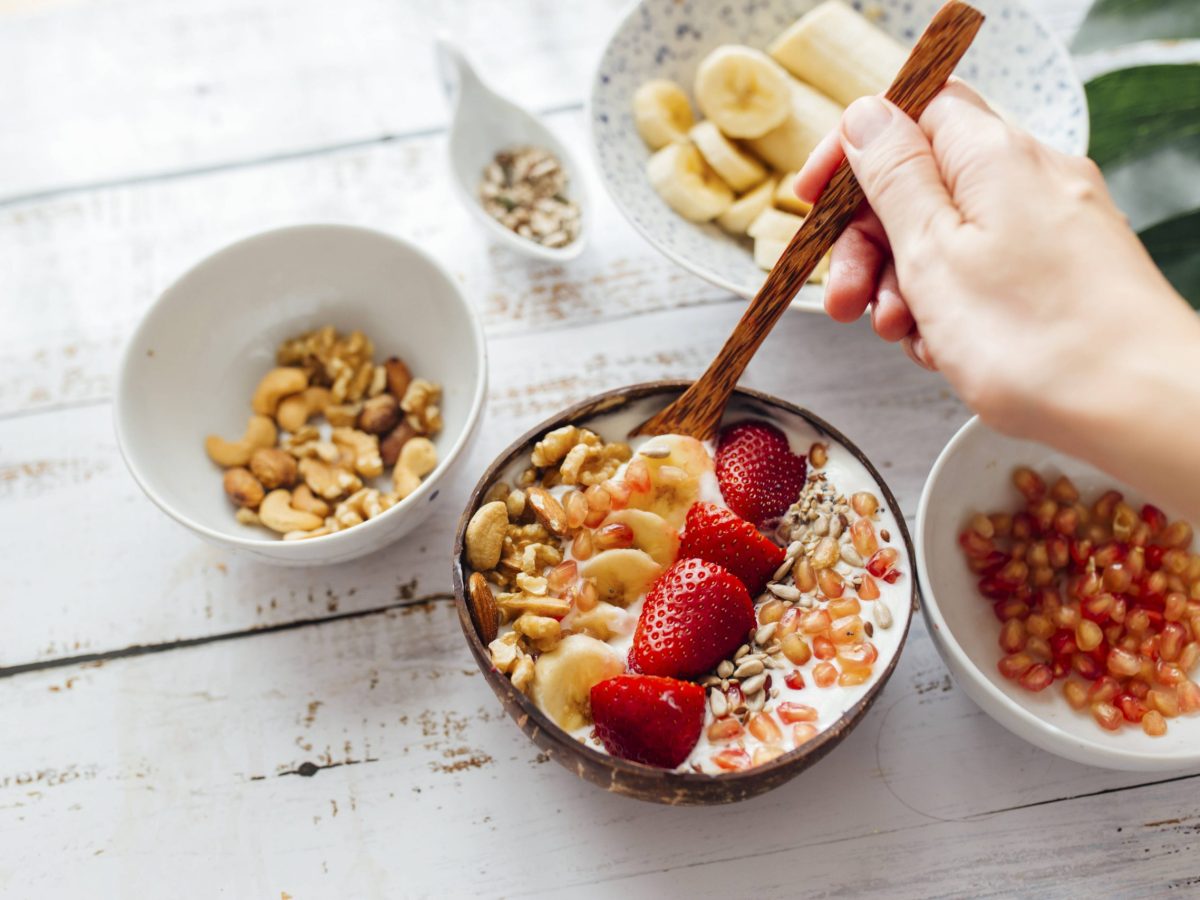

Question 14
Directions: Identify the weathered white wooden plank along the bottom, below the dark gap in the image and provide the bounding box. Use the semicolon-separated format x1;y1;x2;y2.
0;602;1200;898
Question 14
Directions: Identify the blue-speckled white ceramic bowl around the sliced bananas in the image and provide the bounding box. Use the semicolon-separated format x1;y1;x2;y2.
588;0;1087;311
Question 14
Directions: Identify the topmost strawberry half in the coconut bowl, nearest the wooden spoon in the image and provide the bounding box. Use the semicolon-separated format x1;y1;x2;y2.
716;421;808;526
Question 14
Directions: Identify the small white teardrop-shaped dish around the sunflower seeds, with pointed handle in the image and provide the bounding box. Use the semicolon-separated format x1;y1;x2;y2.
434;36;592;263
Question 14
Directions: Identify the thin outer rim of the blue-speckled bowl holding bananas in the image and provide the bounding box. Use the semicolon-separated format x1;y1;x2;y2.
584;0;1091;312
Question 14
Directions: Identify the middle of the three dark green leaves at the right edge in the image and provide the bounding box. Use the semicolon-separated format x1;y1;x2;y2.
1085;65;1200;169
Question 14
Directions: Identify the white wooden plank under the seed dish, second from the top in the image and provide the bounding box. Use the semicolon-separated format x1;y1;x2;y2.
0;113;727;415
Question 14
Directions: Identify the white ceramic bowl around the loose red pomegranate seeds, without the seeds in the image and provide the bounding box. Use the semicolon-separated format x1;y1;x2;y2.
916;419;1200;772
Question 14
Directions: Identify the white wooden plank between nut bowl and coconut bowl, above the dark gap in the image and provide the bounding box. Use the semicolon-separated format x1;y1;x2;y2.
0;301;964;667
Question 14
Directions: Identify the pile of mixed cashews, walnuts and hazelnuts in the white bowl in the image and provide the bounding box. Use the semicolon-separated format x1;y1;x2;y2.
204;325;442;540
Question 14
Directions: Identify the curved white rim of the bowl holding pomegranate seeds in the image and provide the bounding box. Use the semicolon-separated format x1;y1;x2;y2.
914;415;1200;772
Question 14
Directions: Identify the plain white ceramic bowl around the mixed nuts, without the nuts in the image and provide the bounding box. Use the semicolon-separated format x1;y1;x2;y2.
115;224;487;565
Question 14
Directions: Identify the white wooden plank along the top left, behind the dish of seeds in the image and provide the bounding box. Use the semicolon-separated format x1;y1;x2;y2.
0;0;625;199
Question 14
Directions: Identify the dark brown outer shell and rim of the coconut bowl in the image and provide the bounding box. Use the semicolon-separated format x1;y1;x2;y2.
452;380;918;806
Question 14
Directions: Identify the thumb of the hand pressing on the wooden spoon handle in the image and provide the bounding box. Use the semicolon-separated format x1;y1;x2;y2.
841;97;961;260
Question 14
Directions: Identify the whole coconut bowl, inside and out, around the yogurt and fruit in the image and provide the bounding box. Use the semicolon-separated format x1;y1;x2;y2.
452;380;918;805
